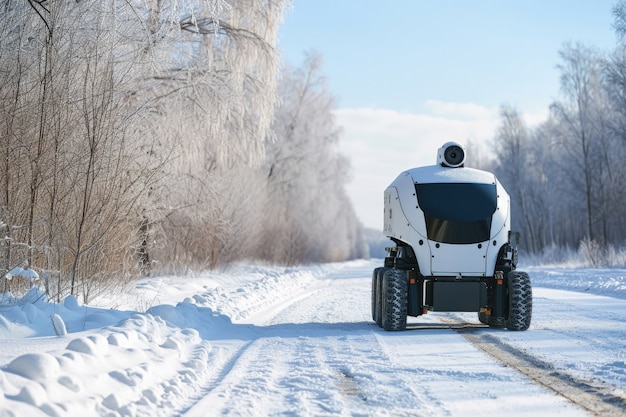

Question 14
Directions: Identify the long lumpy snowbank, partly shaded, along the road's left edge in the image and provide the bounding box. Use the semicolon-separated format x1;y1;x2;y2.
0;265;334;416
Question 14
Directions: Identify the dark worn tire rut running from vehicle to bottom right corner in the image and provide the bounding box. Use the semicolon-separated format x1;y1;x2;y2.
456;329;626;417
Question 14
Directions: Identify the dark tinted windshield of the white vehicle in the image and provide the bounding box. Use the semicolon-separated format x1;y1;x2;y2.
415;183;497;244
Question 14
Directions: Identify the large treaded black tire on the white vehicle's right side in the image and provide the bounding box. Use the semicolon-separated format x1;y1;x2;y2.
504;271;533;331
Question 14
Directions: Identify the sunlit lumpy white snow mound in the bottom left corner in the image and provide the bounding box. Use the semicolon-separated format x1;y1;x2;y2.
0;314;211;416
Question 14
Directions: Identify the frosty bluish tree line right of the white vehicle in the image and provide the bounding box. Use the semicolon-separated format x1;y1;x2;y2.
487;1;626;257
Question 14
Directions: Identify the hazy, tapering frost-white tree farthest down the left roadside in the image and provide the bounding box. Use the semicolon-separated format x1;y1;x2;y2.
265;54;367;263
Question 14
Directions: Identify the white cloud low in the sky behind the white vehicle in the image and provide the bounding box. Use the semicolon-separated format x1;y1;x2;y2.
336;100;545;230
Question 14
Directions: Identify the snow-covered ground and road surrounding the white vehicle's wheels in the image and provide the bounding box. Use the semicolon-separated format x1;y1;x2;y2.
0;260;626;417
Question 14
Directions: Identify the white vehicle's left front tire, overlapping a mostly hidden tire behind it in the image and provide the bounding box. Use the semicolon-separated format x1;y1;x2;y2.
381;268;408;331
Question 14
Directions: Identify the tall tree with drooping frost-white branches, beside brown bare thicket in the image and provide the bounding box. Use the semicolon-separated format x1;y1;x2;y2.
146;0;286;270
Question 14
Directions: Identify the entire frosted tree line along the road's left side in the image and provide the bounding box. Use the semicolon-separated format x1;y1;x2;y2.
0;0;366;302
